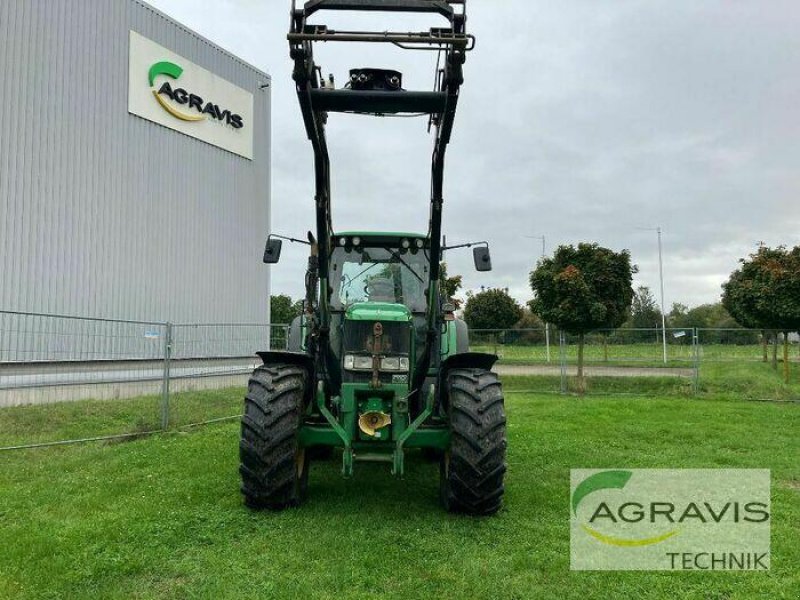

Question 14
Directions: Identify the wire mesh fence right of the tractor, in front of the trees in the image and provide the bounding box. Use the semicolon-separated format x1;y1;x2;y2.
470;326;800;401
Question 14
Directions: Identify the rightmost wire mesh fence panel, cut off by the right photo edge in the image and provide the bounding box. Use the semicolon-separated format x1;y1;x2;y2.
697;329;800;402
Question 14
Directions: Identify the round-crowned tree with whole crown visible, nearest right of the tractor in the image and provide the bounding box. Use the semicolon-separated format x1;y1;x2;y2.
530;243;637;393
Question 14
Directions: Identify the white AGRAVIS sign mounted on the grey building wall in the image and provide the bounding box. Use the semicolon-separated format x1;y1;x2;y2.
128;31;253;159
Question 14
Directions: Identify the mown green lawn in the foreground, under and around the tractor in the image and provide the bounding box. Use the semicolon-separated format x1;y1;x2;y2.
0;378;800;600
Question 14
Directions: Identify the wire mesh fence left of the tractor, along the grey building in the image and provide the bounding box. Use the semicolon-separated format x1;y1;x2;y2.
0;311;287;448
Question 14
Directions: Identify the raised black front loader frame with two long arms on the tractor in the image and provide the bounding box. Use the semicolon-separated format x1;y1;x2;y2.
287;0;475;408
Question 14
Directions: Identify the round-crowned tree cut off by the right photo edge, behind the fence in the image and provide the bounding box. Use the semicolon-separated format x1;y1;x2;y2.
722;246;800;383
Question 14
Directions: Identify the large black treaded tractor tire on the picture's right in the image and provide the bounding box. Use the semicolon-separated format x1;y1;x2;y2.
440;369;507;515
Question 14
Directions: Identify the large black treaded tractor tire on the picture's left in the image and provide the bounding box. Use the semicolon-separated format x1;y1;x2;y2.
239;364;309;510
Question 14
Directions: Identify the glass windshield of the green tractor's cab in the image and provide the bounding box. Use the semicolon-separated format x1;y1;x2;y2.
331;247;428;312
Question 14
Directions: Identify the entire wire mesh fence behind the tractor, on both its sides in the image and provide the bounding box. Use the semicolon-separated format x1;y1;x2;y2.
0;311;800;449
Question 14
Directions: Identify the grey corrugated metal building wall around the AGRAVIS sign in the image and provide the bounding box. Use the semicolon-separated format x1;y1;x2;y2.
0;0;270;322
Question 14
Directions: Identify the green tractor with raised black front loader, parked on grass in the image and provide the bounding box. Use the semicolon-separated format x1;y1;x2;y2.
239;0;506;515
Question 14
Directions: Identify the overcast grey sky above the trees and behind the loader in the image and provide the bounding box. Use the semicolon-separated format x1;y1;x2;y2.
149;0;800;310
